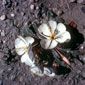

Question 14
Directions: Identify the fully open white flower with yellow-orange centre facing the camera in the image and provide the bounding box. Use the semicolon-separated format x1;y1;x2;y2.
38;20;71;49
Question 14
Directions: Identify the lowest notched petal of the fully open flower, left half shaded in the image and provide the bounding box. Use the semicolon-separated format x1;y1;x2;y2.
40;39;58;49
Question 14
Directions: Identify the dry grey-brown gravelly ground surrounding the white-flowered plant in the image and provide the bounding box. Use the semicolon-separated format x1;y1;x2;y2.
0;0;85;85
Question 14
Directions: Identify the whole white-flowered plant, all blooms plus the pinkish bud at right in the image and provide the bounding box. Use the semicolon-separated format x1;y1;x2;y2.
15;20;71;77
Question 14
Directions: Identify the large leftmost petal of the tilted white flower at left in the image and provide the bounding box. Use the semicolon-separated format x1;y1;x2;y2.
15;38;27;55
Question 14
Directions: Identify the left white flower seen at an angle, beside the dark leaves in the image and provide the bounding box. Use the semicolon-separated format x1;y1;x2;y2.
15;36;35;67
